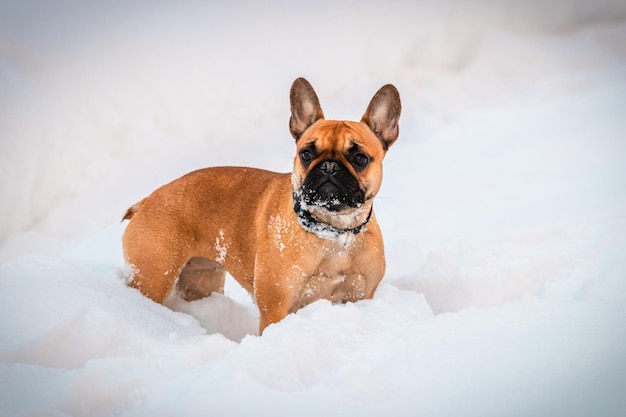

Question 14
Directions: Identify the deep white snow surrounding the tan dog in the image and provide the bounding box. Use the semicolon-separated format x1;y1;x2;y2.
0;0;626;416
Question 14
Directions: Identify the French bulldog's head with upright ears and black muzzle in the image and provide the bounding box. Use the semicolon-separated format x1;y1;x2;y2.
289;78;401;230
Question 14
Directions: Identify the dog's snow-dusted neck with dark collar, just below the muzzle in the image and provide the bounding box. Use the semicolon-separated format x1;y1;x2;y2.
294;195;372;243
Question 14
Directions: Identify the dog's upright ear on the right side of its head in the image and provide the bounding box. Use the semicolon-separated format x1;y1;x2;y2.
361;84;402;150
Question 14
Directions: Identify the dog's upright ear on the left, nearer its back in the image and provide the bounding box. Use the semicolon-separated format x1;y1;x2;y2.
289;78;324;142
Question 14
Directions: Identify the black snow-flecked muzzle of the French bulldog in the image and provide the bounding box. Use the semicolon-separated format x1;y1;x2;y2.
301;158;365;211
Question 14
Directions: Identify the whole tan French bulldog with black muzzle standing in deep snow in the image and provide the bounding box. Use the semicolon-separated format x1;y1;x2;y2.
123;78;400;333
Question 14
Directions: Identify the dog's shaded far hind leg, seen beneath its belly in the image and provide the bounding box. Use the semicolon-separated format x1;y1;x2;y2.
176;256;226;301
